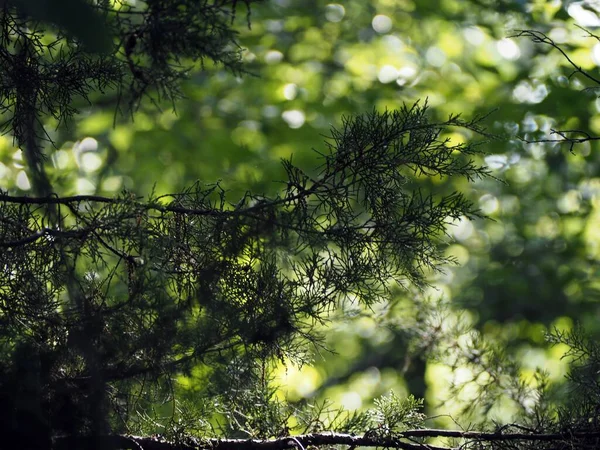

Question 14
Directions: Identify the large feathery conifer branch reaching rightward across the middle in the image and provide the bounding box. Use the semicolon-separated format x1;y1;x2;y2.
0;99;485;442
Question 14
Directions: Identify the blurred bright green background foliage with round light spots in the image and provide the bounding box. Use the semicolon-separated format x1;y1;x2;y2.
0;0;600;448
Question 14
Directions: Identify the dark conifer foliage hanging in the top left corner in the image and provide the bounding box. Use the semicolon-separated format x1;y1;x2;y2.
0;0;252;196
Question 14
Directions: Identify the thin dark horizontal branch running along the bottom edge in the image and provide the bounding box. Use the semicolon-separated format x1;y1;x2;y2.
55;429;600;450
